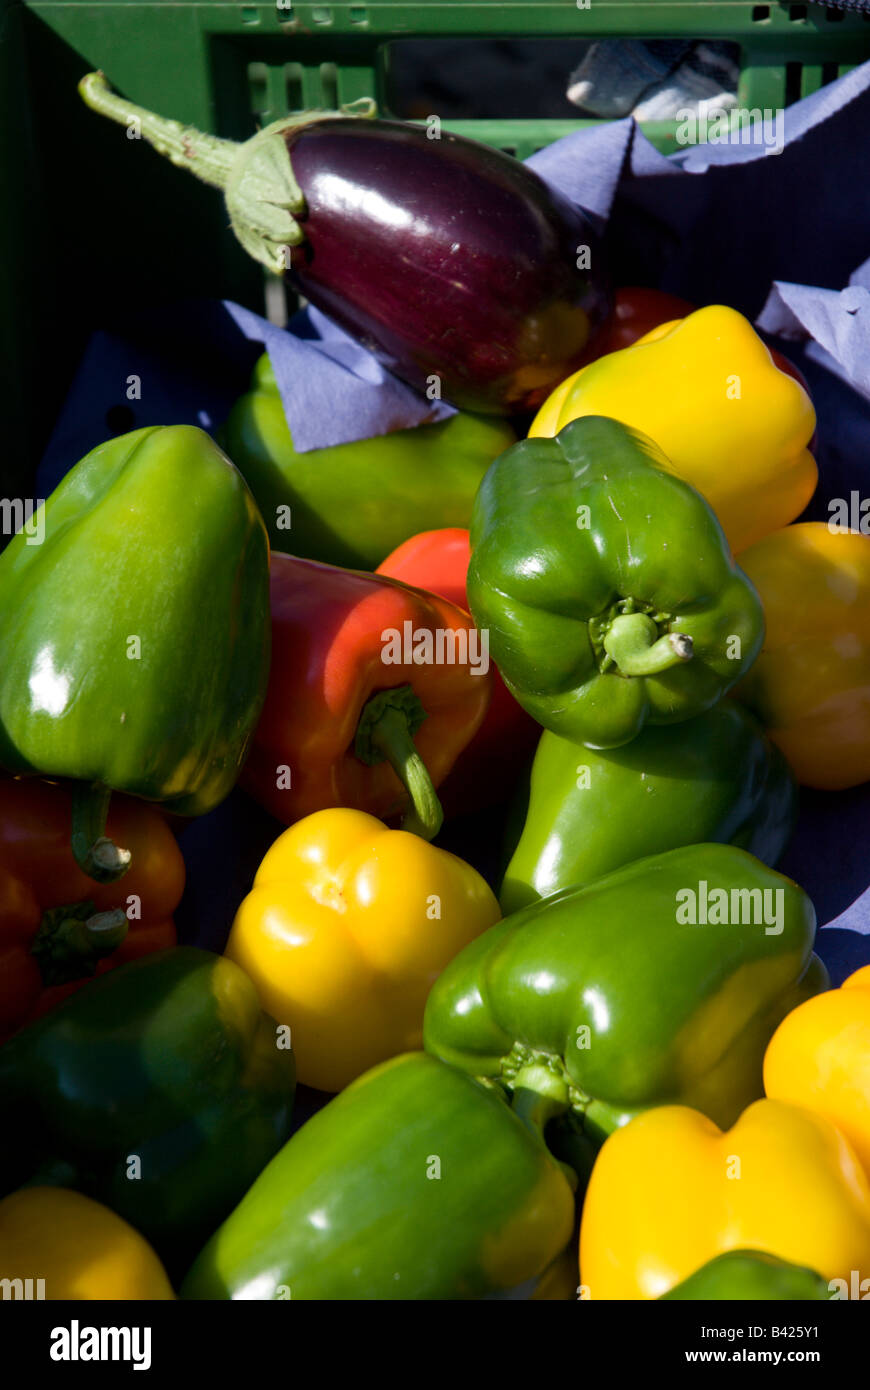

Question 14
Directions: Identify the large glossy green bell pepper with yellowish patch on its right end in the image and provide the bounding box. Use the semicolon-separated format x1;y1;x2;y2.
424;845;828;1143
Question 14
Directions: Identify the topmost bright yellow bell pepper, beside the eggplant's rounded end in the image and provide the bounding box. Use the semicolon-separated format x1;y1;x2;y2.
530;304;819;553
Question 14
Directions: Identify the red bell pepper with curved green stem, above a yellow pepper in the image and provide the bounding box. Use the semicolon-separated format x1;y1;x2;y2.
242;553;492;840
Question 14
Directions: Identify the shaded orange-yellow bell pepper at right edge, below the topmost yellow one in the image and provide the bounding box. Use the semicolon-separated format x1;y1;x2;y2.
734;521;870;791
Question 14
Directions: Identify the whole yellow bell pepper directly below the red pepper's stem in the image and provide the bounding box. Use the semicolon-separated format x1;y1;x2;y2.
219;809;500;1091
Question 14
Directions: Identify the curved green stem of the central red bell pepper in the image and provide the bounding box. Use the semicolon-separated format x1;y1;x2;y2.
353;685;443;840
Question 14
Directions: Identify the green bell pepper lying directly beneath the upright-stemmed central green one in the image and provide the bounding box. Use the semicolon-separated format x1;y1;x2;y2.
500;699;798;916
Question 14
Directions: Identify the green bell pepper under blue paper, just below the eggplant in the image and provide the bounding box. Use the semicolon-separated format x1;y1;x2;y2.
220;356;516;570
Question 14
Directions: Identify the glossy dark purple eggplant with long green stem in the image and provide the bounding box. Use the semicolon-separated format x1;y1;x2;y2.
79;72;610;414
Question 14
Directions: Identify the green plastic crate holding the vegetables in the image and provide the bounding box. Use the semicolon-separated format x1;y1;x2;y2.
0;0;870;483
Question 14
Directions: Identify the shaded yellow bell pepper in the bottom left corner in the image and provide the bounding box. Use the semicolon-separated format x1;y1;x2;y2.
0;1187;175;1301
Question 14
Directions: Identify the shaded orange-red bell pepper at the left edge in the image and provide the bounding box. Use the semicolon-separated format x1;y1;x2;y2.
0;778;185;1040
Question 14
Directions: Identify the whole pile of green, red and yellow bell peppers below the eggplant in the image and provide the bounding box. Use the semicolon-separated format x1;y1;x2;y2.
0;258;870;1300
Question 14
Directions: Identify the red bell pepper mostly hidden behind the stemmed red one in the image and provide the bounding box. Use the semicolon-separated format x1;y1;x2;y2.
377;527;541;813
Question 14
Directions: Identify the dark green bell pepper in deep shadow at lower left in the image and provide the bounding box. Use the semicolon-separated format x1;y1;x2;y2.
0;947;296;1273
